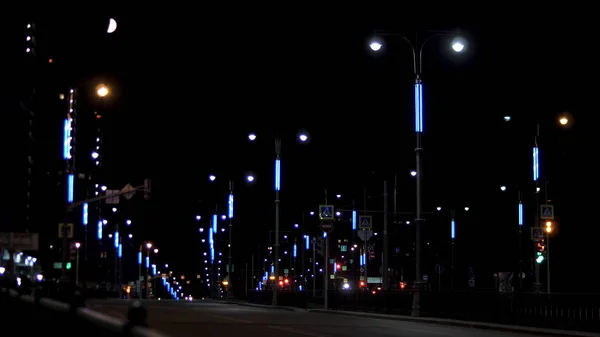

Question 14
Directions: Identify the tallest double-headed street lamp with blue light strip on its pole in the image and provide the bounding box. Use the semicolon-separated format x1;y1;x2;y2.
369;32;466;316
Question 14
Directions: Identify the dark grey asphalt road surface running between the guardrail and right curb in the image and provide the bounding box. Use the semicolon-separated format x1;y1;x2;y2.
88;300;552;337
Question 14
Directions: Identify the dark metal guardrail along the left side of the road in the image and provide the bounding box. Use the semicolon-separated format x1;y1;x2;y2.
0;288;168;337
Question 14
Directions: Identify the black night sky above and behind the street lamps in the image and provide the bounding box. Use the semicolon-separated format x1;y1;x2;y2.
2;8;600;291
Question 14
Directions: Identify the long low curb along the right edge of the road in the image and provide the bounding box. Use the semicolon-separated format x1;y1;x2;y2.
307;309;599;337
